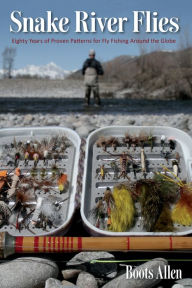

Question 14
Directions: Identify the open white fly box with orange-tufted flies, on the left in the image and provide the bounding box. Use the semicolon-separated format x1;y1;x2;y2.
0;127;80;236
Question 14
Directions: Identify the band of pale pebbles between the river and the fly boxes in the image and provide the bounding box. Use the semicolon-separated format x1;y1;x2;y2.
0;113;192;137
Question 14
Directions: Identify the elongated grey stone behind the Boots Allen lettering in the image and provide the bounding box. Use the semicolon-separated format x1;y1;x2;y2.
102;258;168;288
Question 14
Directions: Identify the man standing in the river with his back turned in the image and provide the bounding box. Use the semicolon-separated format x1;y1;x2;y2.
82;49;104;106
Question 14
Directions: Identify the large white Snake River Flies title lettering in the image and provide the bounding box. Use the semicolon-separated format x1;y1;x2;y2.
9;10;180;33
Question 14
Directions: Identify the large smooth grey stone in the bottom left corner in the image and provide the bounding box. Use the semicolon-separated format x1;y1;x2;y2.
0;257;59;288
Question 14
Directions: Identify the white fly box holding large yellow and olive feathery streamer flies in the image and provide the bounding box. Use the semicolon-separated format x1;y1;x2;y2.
81;126;192;236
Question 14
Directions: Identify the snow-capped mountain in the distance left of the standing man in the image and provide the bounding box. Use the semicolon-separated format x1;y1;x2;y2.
0;62;71;79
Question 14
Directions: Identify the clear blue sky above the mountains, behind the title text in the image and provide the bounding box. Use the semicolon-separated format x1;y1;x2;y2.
0;0;192;70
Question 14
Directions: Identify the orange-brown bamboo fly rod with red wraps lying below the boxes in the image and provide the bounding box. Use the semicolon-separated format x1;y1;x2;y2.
0;232;192;258
